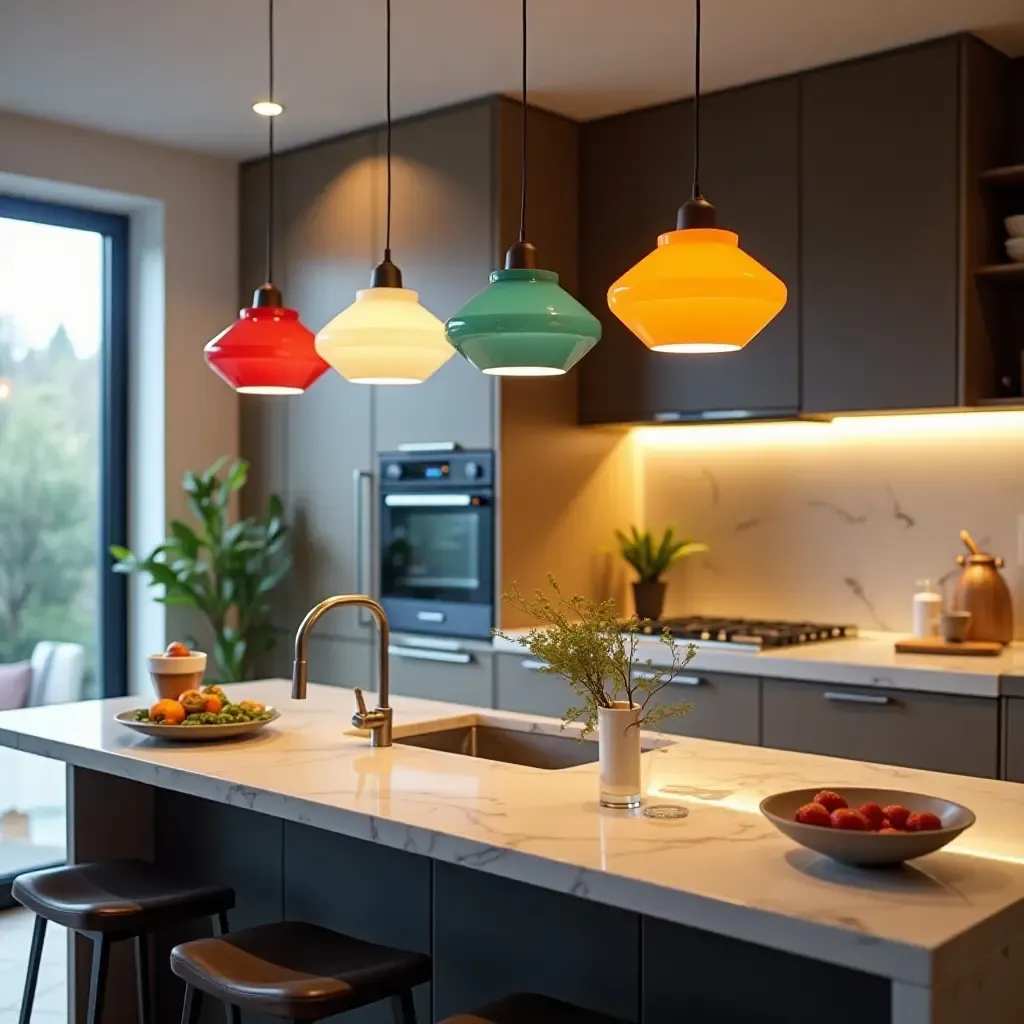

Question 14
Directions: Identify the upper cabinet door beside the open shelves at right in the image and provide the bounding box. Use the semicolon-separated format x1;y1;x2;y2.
801;40;959;413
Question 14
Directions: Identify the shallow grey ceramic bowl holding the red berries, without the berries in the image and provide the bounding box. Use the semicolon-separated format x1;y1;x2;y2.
761;785;975;867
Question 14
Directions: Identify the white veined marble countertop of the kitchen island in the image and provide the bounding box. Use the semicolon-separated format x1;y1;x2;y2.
0;680;1024;985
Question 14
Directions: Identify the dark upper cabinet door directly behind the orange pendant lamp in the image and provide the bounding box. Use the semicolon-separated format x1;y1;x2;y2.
580;79;800;423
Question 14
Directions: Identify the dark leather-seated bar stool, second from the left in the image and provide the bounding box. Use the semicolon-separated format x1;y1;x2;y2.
171;922;430;1024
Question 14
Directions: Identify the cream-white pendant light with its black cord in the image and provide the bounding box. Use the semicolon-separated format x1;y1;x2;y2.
316;0;455;384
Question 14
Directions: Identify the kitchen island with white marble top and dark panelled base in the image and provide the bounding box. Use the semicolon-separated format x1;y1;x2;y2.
0;680;1024;1024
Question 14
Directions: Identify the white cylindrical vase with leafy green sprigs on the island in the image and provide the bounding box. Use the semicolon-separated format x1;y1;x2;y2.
495;575;696;807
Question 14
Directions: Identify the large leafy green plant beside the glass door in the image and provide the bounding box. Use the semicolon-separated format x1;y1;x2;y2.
111;457;292;683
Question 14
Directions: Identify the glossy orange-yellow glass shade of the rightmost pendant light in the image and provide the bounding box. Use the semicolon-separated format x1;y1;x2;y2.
608;227;786;352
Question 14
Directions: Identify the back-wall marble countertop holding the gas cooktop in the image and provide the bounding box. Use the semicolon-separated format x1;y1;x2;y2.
494;630;1024;697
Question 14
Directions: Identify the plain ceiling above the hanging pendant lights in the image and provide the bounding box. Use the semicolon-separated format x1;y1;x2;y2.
6;0;1024;158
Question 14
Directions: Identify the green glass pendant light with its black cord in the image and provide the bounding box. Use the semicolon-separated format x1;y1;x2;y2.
444;0;601;377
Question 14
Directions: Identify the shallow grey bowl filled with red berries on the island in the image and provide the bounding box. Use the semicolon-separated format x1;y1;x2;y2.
761;785;975;867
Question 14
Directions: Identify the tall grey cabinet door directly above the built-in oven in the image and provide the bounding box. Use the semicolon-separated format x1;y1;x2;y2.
374;103;497;452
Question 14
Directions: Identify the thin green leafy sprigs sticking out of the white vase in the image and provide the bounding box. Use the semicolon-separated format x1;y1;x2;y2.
495;573;697;735
